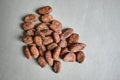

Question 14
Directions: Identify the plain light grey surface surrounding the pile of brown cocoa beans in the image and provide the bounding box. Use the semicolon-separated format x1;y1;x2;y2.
0;0;120;80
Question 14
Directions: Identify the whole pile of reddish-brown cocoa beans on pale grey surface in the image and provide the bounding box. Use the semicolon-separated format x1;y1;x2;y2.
22;6;86;73
